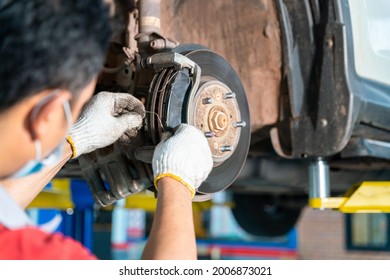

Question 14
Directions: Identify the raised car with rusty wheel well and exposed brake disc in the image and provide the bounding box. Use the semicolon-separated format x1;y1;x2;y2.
61;0;390;236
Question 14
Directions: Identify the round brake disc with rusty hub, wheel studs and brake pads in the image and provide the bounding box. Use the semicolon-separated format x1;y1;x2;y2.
147;45;250;194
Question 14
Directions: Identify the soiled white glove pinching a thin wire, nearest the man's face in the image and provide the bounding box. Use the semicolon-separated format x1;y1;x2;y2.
67;92;145;158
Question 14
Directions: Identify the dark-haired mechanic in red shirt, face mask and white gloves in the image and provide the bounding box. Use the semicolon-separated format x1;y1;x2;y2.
0;0;212;259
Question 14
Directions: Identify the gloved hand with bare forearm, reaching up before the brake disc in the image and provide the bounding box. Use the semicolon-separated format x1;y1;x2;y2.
142;124;213;260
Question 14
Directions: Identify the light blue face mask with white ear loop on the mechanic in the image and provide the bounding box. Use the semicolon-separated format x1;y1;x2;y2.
9;92;72;178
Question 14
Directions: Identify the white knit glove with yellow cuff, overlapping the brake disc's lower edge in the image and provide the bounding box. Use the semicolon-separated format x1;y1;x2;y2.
152;124;213;197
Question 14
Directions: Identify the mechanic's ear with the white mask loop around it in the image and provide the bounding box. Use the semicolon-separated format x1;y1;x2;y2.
30;90;71;139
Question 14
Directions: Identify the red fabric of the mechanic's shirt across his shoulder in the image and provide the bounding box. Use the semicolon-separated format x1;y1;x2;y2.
0;225;96;260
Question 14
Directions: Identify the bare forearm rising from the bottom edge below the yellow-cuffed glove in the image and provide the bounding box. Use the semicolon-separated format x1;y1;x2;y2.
142;178;197;260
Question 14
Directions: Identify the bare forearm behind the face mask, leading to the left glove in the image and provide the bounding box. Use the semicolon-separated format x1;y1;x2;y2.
0;142;72;208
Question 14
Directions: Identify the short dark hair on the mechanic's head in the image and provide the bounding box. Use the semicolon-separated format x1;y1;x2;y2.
0;0;111;112
